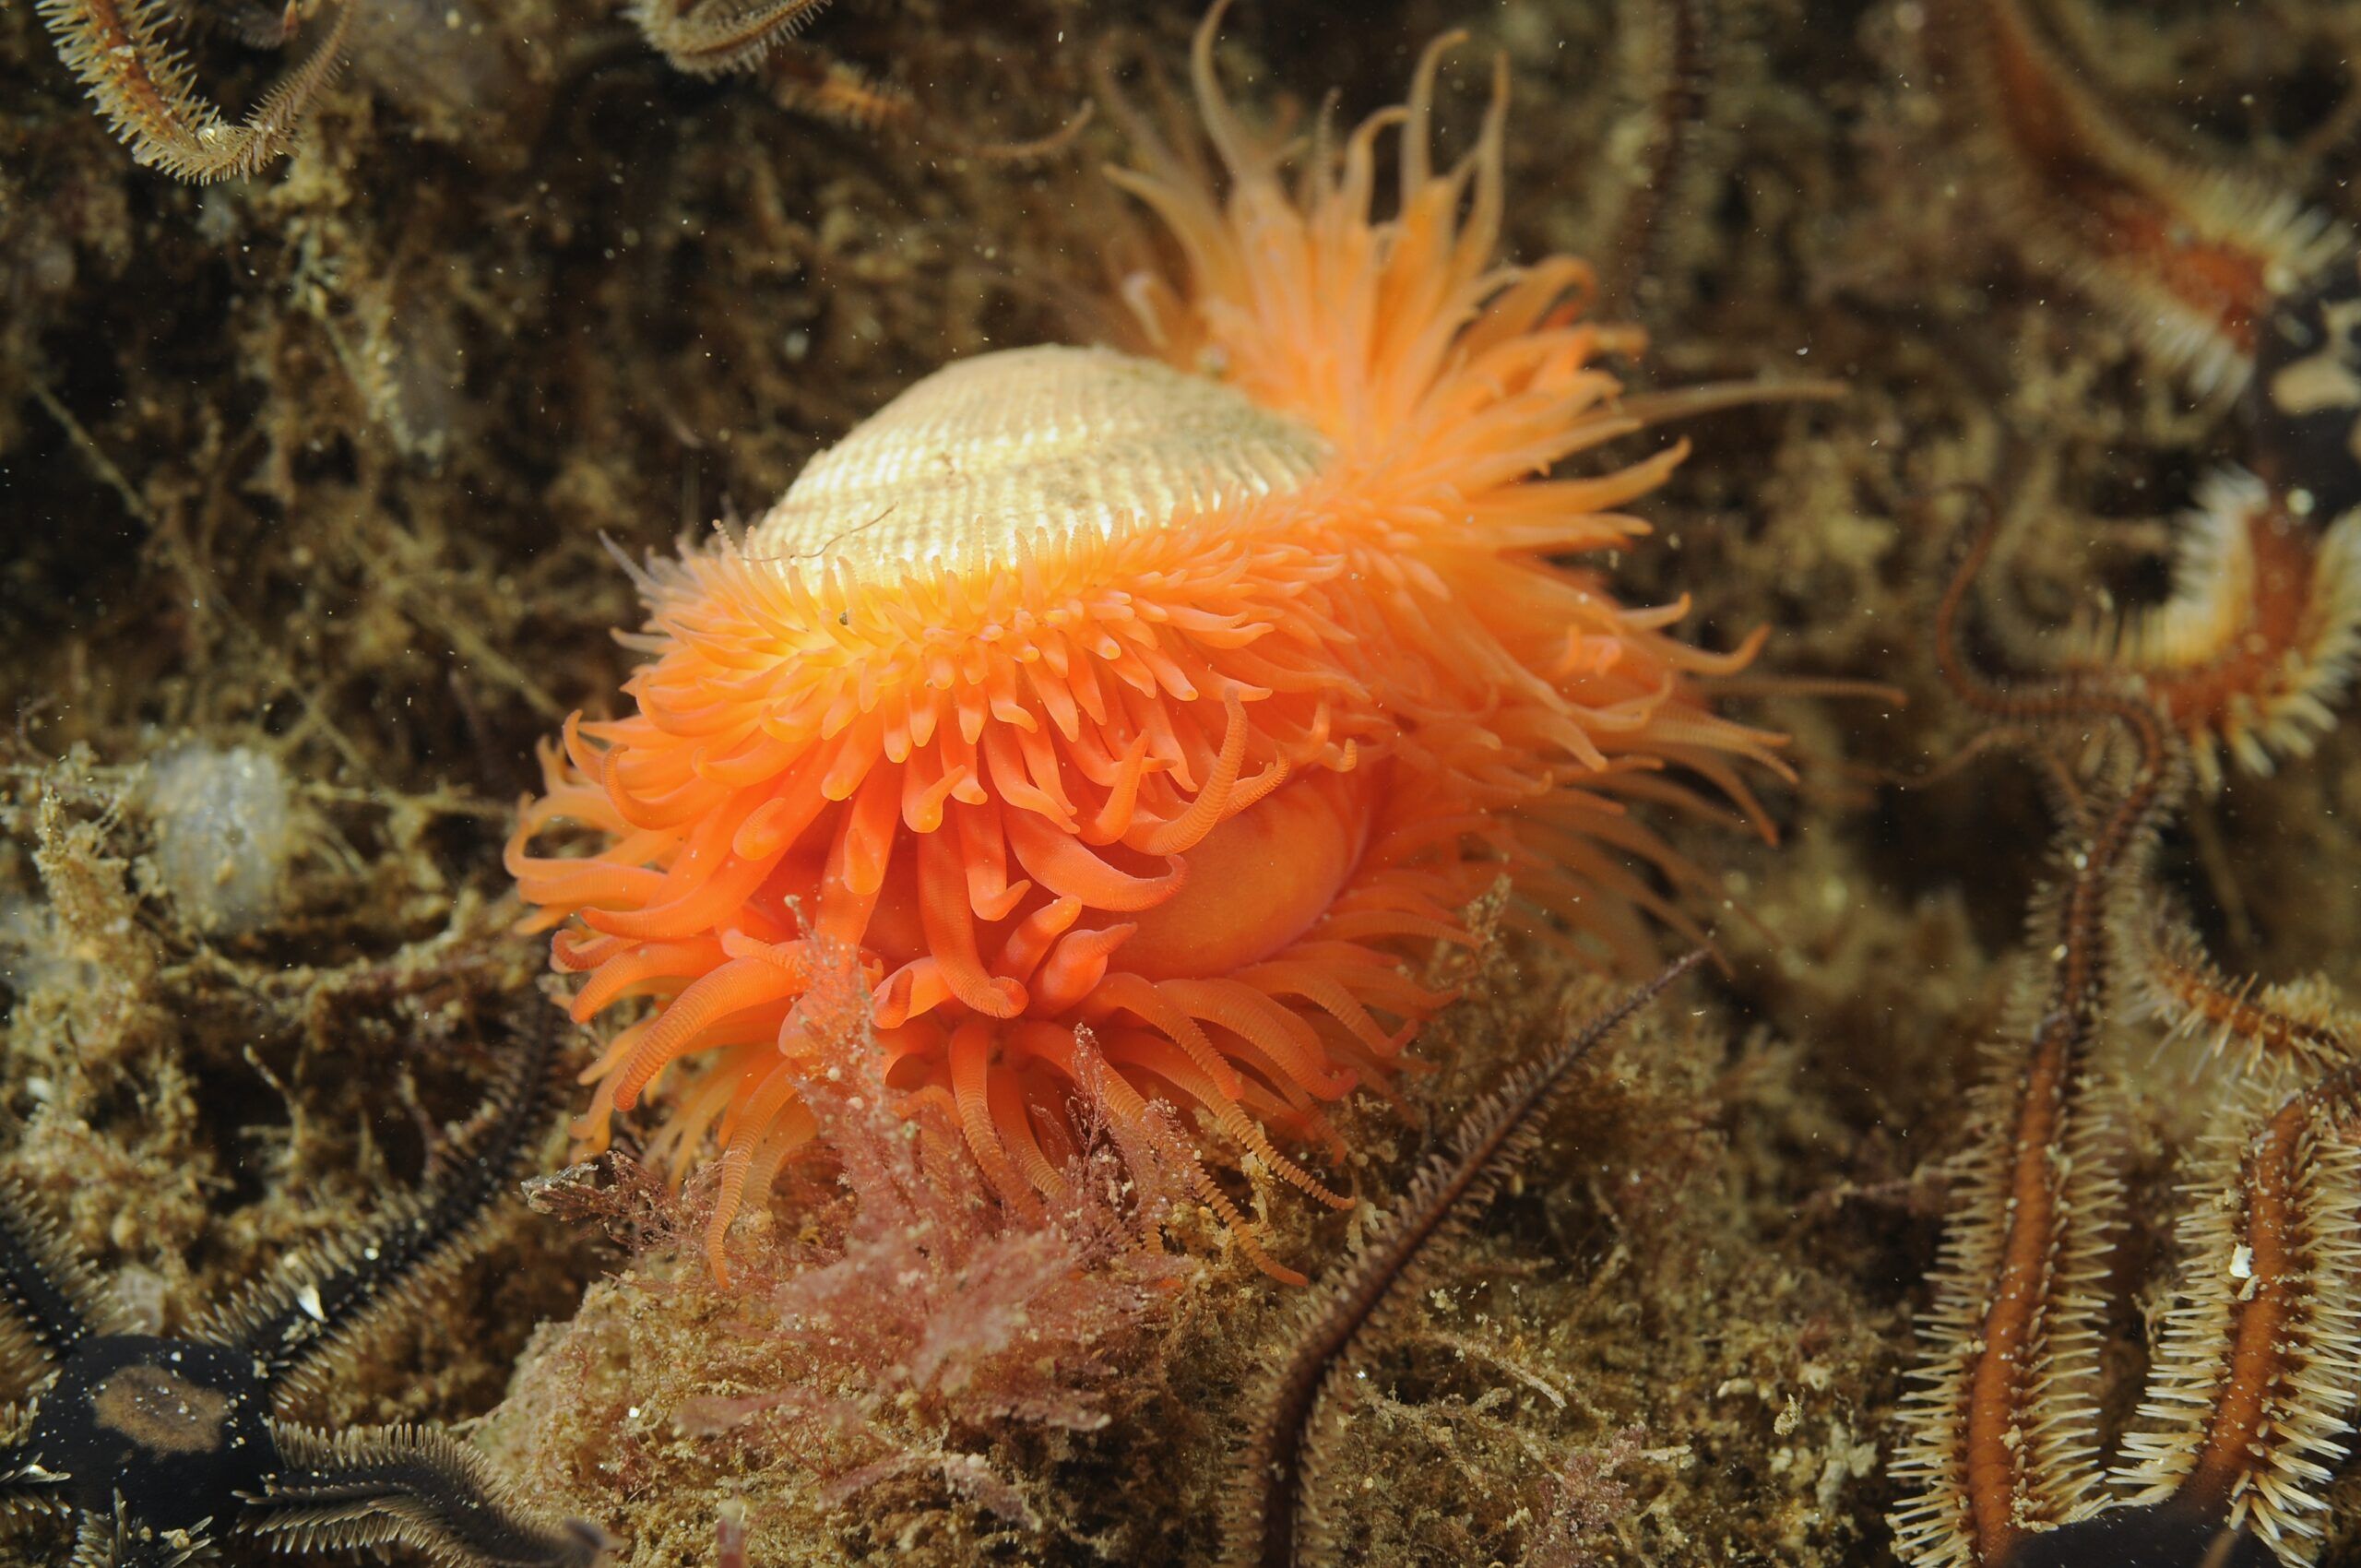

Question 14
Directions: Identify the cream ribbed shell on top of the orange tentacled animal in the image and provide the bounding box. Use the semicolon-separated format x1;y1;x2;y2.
749;347;1329;583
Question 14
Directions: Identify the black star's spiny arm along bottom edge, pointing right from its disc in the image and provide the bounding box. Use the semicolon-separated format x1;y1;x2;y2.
239;1421;614;1568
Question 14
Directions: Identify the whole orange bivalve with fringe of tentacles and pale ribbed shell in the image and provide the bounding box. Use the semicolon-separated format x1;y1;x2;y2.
510;9;1771;1277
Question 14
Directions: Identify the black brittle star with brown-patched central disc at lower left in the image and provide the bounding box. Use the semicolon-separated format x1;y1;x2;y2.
0;1010;614;1568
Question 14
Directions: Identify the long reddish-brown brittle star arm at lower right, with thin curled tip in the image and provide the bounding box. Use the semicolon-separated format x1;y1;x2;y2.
1892;498;2179;1568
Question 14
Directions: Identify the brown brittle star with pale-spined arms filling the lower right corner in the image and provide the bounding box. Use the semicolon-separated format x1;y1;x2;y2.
1892;493;2361;1568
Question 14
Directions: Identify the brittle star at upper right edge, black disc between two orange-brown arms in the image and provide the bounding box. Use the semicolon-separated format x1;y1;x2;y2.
1919;0;2361;793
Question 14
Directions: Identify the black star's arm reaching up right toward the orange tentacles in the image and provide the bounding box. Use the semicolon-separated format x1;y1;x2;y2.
196;1028;557;1394
